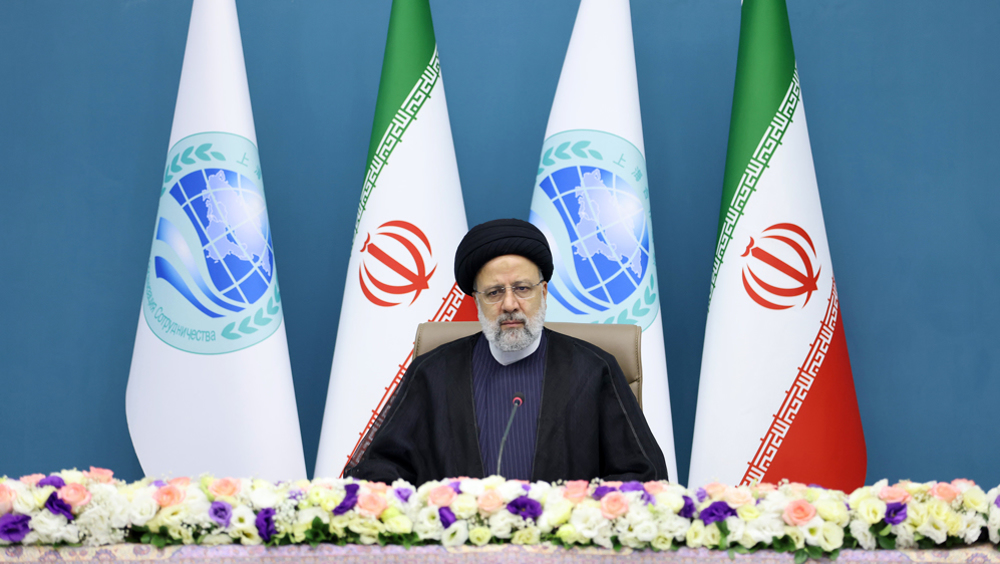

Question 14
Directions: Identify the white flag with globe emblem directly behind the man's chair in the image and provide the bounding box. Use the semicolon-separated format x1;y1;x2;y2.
529;0;677;480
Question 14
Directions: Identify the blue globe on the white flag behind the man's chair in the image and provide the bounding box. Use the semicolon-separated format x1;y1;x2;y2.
539;166;650;313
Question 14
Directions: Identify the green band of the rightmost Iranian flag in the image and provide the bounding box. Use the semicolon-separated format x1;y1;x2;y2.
709;0;799;305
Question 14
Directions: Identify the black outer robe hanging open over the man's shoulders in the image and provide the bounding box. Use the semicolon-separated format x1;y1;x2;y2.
345;329;667;485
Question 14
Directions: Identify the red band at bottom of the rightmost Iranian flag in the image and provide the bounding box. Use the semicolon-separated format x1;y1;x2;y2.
741;281;868;491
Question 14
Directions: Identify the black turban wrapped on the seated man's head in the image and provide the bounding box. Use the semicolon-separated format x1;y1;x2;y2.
455;219;552;294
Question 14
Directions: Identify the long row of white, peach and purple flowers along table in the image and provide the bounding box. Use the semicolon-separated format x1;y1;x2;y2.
0;467;1000;564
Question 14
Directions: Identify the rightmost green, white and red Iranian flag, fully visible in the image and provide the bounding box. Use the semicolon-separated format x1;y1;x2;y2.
689;0;867;491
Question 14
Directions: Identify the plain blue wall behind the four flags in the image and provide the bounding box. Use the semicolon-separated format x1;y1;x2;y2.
0;0;1000;486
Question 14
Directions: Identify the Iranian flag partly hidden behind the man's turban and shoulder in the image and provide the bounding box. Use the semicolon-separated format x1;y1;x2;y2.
315;0;477;477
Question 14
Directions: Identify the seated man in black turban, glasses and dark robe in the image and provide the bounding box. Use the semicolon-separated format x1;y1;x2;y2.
346;219;667;484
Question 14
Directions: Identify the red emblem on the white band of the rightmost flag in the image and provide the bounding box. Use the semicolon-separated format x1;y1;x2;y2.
740;223;823;310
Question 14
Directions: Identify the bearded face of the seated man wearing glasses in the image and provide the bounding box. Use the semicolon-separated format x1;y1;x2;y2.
476;255;548;351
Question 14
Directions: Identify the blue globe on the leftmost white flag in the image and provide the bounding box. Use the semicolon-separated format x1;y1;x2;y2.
154;169;274;318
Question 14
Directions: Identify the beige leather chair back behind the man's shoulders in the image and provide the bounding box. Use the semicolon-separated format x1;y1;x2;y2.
413;321;642;408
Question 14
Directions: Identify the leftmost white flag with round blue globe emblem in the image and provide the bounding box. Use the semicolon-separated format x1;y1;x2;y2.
125;0;306;480
